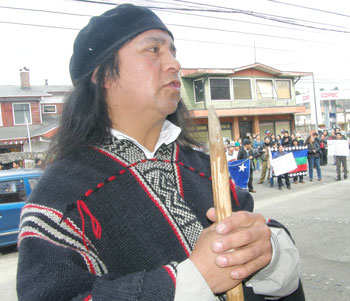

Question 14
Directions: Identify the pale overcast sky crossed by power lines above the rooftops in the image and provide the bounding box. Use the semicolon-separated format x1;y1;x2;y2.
0;0;350;89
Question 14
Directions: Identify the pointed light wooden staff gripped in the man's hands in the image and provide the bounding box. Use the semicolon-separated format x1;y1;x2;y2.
208;106;244;301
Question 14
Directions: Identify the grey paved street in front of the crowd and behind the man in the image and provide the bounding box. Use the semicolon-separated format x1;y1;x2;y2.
0;161;350;301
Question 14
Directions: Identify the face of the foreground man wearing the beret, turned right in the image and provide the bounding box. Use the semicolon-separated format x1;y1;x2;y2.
105;30;181;122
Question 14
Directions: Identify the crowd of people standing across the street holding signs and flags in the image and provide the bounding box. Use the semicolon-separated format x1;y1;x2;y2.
226;128;348;192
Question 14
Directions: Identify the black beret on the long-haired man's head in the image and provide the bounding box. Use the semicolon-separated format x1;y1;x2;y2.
69;4;174;84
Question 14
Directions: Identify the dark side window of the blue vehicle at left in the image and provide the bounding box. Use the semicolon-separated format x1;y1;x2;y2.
0;180;26;204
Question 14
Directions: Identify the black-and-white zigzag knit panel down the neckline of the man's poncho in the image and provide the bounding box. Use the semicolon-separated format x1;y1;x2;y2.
102;137;203;253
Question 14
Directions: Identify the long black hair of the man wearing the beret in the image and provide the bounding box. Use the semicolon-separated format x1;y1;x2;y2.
47;51;199;162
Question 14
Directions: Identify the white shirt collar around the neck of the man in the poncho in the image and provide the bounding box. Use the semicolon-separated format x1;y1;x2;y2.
111;120;181;159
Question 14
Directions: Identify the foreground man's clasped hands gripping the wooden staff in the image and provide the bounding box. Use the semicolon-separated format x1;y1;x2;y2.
190;208;272;293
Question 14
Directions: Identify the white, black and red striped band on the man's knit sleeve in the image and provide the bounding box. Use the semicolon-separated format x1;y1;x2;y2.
18;203;108;276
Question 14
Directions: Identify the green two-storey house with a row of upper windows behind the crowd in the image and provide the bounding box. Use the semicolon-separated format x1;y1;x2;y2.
181;63;311;142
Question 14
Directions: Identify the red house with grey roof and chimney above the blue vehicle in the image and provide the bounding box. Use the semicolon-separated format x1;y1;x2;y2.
0;68;71;154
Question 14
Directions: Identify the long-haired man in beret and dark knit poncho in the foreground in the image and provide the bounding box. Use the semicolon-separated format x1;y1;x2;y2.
17;4;304;301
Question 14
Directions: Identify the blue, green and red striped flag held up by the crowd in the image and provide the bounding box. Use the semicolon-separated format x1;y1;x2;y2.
270;146;307;178
